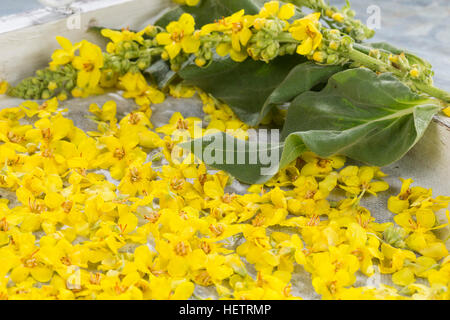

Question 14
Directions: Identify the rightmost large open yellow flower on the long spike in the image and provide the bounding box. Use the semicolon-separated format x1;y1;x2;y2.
289;12;322;55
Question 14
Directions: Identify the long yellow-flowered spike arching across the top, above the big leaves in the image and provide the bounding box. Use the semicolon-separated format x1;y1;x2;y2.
7;1;450;101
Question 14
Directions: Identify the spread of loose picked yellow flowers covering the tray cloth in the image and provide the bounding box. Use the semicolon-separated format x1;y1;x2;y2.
0;87;450;299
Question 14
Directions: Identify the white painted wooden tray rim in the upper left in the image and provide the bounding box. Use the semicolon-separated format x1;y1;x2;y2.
0;0;171;83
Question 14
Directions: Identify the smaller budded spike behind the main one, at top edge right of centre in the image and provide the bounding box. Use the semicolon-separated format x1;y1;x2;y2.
287;0;375;42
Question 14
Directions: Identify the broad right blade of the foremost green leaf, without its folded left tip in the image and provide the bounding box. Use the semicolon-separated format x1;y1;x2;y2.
282;69;440;166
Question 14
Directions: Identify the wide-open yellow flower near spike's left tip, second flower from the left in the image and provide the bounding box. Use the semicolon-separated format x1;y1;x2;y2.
72;40;103;89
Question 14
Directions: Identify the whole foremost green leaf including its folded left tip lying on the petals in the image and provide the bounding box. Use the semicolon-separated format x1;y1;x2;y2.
181;69;439;183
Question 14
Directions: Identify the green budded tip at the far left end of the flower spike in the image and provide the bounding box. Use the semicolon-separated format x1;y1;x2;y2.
10;65;77;100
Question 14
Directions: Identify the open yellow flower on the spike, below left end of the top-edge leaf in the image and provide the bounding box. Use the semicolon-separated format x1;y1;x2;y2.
156;13;200;59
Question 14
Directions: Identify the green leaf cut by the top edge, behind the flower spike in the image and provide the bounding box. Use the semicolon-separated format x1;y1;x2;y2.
156;0;264;27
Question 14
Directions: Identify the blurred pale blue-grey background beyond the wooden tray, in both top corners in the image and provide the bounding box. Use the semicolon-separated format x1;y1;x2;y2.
0;0;450;90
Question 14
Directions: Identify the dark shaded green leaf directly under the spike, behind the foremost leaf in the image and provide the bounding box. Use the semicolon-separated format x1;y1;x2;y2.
178;55;342;126
